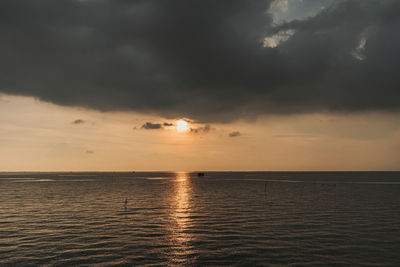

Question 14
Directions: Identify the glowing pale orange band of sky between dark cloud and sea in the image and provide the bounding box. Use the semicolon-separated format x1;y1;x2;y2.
0;95;400;171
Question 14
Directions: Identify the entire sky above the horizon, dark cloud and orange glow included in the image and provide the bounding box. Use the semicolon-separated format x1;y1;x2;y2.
0;0;400;171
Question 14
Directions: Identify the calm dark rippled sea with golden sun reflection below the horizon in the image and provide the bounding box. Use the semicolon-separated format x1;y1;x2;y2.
0;172;400;266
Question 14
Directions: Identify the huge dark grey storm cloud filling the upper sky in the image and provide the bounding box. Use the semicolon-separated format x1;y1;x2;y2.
0;0;400;122
